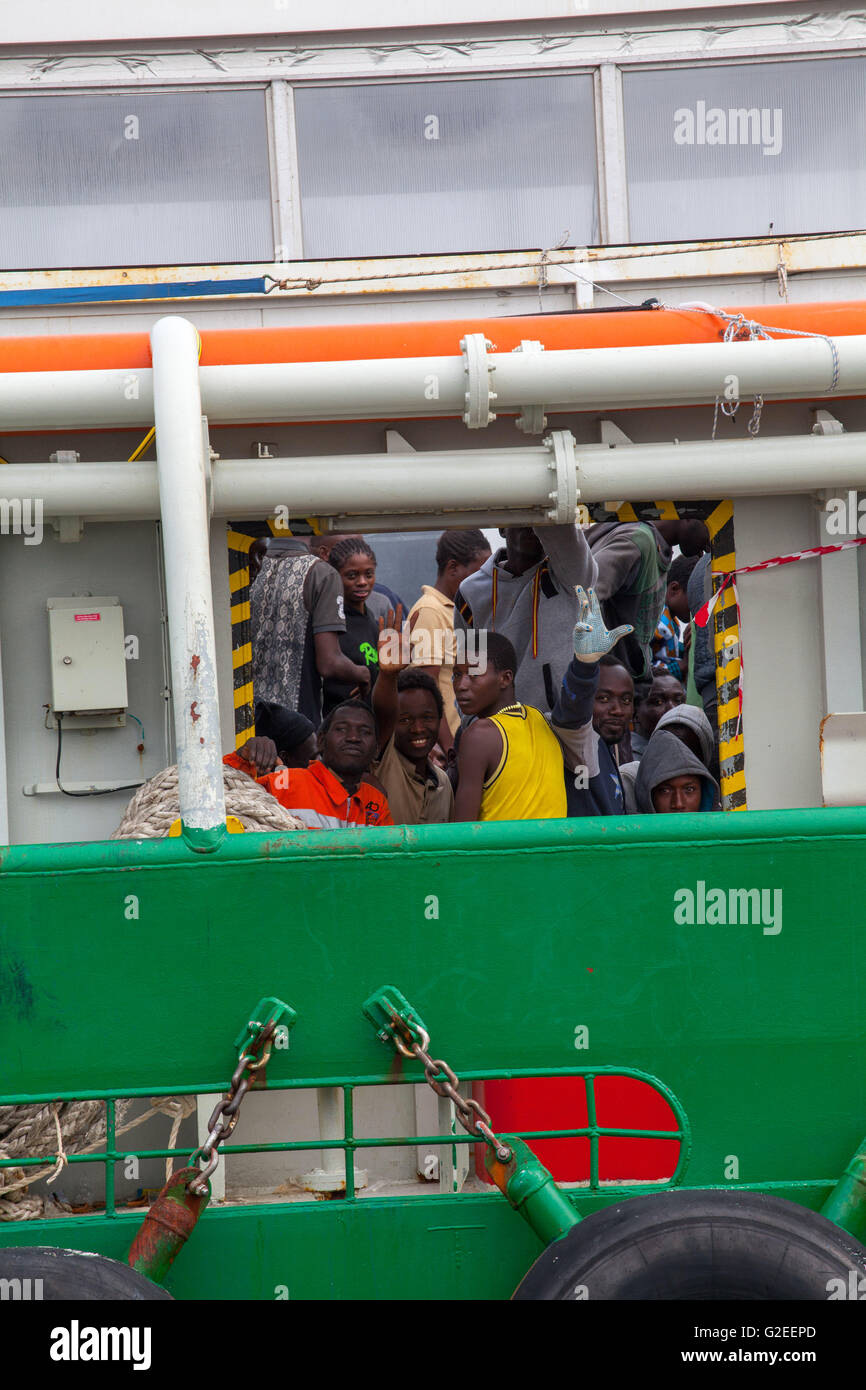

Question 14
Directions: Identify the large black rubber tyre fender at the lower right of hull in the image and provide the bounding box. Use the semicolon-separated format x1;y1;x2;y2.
513;1191;866;1301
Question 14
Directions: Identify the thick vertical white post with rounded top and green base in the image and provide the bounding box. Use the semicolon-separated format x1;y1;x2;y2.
150;317;225;851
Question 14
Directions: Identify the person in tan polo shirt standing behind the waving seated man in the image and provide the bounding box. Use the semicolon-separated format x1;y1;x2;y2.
409;531;491;752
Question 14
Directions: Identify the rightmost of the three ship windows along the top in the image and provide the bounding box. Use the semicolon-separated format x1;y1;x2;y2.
623;58;866;242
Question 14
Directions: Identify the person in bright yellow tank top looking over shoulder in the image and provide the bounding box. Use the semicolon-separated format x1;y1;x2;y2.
455;631;566;820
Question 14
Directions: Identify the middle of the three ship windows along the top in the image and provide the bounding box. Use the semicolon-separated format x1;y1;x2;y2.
295;75;598;259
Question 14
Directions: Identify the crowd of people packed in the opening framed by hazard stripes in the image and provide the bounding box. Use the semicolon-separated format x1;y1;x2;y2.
225;520;720;830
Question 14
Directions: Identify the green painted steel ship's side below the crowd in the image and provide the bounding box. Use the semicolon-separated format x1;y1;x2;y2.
0;808;866;1300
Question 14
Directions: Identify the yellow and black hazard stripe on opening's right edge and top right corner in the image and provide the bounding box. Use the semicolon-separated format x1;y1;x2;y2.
614;500;746;810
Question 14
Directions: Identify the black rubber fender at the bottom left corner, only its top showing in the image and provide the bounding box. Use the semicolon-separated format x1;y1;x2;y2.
0;1245;171;1302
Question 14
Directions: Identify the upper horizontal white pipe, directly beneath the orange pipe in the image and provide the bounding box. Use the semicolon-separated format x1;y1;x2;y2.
0;332;866;430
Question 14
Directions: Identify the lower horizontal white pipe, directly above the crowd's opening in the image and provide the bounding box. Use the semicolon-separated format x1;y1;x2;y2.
10;428;866;530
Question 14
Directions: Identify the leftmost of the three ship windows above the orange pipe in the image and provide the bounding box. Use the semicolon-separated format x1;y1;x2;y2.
0;89;274;270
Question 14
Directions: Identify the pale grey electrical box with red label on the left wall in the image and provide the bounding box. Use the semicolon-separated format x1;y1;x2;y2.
47;598;128;723
